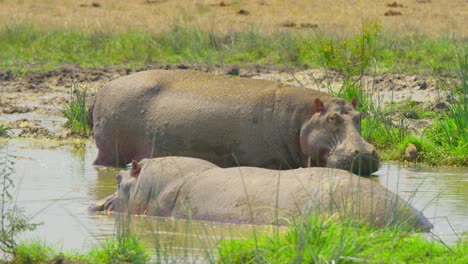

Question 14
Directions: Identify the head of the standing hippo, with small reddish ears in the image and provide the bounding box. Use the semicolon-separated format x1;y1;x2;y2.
299;99;379;175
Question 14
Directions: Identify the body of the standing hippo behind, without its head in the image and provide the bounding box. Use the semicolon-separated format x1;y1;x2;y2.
93;70;334;168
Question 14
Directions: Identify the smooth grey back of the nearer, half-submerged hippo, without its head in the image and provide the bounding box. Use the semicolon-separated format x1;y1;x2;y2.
153;167;432;231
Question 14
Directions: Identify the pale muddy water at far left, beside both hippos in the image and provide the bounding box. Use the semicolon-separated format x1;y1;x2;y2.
0;140;115;252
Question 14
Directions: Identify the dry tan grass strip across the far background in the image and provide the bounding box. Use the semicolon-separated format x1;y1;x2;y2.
0;0;468;37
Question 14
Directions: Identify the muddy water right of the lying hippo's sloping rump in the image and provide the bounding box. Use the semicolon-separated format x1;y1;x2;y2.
375;163;468;243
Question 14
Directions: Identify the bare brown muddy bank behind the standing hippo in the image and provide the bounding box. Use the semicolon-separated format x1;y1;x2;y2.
0;65;451;139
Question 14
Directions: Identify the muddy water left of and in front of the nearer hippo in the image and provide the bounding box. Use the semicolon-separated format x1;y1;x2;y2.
0;140;273;262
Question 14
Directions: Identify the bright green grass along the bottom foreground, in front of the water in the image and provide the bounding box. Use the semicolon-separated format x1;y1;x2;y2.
8;216;468;263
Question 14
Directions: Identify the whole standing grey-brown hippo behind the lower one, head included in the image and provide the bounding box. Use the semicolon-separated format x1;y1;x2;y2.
90;70;379;175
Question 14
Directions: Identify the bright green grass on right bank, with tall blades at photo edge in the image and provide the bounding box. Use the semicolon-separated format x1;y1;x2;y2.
370;48;468;166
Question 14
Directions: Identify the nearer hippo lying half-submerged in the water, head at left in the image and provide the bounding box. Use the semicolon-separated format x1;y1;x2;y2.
90;157;432;231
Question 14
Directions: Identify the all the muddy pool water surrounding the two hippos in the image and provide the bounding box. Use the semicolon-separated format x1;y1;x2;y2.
0;140;468;255
